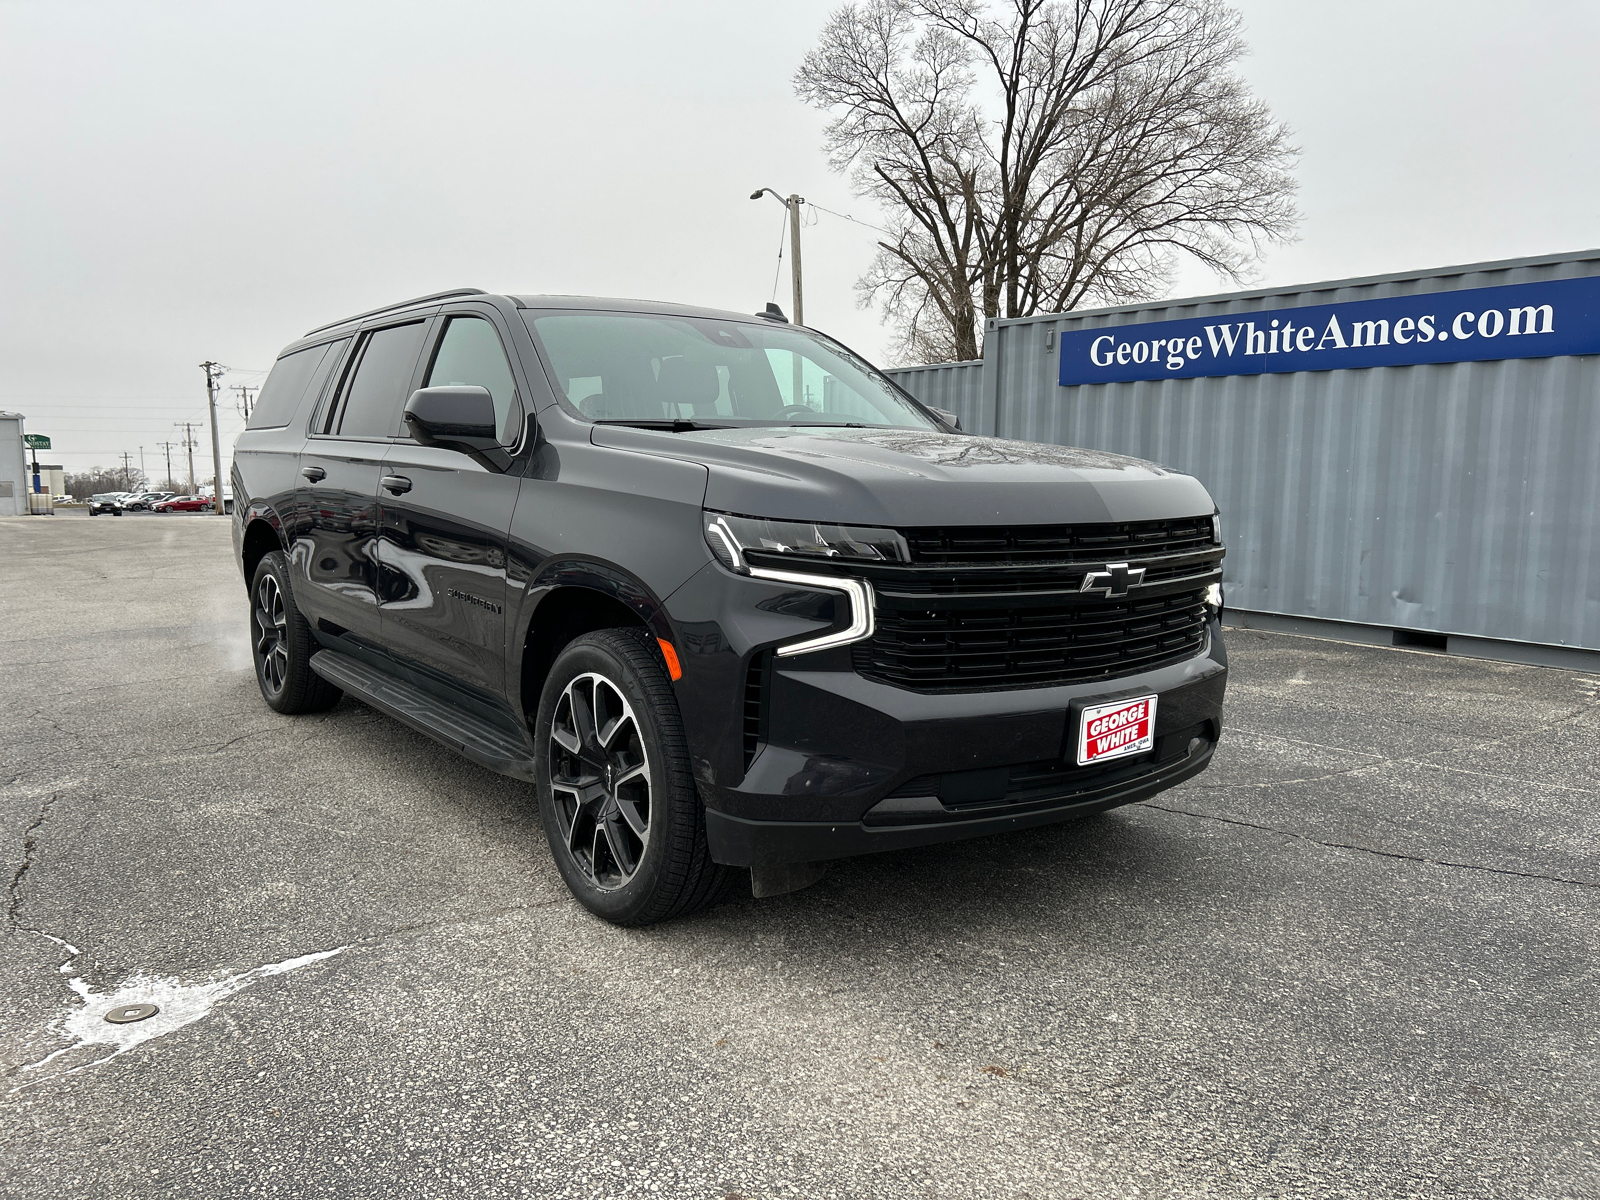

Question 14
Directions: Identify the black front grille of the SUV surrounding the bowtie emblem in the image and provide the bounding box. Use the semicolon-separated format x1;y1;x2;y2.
851;518;1222;693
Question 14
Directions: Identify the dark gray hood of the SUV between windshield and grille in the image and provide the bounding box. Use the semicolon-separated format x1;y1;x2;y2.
592;426;1216;528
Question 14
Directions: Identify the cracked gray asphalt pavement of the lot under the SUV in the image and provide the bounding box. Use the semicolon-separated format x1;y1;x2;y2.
0;514;1600;1200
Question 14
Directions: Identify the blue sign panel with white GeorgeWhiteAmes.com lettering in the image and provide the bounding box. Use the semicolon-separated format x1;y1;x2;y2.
1061;275;1600;387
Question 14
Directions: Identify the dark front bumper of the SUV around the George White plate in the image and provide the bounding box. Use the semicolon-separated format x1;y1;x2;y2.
667;560;1227;867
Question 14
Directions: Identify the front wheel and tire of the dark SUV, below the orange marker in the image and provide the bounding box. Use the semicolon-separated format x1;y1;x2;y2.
534;629;730;925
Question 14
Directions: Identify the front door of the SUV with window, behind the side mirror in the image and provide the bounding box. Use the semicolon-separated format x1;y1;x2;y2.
379;304;528;707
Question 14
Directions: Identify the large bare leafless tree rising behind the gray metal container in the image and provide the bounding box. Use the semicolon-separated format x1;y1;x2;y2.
795;0;1298;362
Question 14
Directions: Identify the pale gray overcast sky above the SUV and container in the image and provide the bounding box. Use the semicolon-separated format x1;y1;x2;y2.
0;0;1600;477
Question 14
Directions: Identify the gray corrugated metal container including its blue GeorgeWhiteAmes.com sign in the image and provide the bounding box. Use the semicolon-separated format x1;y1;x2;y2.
890;251;1600;670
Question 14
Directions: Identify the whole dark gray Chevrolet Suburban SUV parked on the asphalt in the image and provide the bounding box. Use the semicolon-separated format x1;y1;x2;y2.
232;290;1227;925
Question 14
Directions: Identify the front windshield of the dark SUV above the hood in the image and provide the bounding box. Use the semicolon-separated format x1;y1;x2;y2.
525;312;938;429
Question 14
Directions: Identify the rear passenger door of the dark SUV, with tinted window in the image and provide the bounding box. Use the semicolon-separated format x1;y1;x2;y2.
291;318;432;643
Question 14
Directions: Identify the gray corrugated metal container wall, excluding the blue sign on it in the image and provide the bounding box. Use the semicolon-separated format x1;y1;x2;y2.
891;251;1600;650
